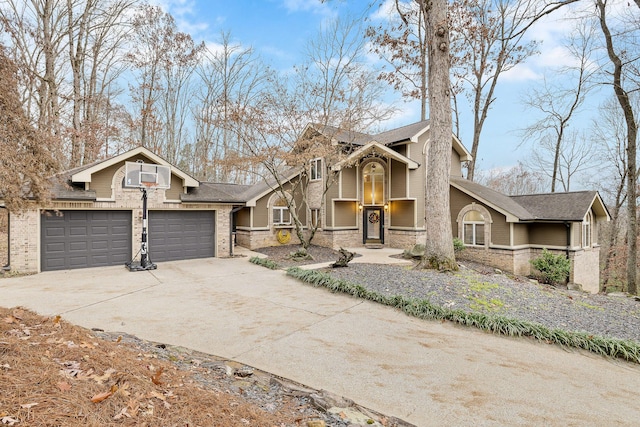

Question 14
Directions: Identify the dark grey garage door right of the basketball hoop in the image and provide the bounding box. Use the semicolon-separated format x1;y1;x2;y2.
149;211;216;262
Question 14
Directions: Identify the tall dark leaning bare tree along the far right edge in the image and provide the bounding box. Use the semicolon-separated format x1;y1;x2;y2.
596;0;638;294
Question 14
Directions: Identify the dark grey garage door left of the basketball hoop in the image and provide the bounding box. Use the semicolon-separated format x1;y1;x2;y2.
40;211;131;271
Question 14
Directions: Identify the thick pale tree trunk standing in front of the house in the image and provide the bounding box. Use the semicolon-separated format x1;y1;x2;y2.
420;0;458;270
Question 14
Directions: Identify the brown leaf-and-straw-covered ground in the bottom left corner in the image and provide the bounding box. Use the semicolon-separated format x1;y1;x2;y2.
0;307;308;426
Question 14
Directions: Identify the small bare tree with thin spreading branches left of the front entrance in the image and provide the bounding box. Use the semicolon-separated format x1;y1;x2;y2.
233;15;393;250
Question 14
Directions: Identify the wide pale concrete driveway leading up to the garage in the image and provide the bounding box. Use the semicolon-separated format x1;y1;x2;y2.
0;258;640;426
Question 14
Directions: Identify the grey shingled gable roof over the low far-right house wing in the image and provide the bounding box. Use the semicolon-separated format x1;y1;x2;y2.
510;191;610;221
